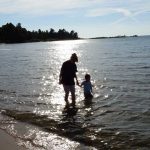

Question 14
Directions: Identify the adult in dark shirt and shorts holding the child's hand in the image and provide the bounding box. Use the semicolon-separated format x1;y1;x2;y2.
59;53;79;106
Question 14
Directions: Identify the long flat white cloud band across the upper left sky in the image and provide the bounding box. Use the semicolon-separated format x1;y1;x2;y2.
0;0;96;15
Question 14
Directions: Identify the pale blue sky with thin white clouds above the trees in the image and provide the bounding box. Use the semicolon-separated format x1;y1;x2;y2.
0;0;150;38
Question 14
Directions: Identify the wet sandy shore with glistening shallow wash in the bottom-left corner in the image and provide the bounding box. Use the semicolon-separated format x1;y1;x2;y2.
0;114;95;150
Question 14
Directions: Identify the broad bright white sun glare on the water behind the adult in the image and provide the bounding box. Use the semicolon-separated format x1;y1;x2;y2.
34;40;87;119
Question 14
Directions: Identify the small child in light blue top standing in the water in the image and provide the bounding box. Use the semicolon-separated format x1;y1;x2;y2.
81;74;93;99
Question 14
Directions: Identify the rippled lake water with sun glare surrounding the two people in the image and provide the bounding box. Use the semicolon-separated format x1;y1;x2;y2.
0;36;150;150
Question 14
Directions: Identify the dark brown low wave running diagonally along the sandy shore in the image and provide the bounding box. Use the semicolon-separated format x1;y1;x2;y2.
2;106;149;150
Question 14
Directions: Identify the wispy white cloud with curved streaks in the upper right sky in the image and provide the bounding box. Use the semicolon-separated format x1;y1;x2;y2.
87;0;150;25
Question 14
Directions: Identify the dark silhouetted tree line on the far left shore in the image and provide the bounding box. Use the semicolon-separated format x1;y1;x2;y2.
0;23;78;43
